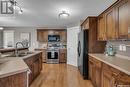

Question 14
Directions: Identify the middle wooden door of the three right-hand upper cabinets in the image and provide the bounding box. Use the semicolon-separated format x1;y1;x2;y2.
105;8;116;40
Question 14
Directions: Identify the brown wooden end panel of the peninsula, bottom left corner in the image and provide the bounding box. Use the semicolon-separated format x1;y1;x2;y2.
0;72;27;87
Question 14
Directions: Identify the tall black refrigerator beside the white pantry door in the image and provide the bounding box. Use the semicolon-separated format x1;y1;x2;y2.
78;30;89;79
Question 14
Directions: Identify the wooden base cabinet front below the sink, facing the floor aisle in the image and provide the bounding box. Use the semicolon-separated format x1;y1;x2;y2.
24;53;42;84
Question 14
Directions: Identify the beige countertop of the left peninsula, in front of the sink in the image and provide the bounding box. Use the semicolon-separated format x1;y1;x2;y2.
0;51;41;78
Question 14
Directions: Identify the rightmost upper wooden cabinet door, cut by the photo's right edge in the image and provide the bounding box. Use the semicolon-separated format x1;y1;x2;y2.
116;0;130;39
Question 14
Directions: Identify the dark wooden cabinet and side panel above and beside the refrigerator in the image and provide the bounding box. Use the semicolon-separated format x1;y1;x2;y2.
81;17;106;53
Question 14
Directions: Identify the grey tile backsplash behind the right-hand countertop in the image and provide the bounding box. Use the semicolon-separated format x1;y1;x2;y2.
107;41;130;57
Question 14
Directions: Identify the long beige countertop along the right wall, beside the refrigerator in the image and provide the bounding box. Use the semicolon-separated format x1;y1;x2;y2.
89;54;130;75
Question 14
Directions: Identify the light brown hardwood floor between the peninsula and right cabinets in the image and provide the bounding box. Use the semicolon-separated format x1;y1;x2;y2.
30;64;93;87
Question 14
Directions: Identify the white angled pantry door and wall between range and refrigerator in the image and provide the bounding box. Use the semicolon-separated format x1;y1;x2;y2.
67;26;80;66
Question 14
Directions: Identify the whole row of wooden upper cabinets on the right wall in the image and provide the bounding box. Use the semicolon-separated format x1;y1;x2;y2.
98;0;130;41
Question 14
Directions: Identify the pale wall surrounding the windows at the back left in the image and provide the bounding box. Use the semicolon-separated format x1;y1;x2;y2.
4;27;38;50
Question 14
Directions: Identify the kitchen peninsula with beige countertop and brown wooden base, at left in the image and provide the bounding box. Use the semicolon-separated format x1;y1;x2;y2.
0;48;42;87
